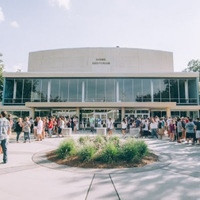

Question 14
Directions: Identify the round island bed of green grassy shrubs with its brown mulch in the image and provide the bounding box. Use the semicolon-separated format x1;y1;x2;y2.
47;136;158;168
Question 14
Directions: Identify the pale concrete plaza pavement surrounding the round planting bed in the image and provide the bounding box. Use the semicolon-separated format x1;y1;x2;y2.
0;135;200;200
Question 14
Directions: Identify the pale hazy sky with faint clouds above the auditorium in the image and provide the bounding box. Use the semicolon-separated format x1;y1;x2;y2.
0;0;200;72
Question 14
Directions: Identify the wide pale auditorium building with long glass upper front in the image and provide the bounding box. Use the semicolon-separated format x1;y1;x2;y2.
0;47;200;125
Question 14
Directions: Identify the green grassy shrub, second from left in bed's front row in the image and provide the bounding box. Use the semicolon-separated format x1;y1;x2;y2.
78;143;96;161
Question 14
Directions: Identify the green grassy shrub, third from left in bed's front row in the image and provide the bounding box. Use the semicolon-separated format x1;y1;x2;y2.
96;142;118;163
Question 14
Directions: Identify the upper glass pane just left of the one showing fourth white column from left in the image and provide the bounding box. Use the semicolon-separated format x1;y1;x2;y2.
106;79;115;102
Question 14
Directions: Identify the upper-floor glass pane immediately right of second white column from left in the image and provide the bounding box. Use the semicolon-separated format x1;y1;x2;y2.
50;79;60;102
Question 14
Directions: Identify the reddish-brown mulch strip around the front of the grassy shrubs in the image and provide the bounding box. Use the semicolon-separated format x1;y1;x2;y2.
46;151;158;169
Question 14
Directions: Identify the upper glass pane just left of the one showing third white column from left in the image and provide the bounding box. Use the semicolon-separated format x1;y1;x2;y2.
69;79;78;102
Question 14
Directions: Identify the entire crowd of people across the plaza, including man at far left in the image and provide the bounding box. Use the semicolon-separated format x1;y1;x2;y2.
0;111;200;163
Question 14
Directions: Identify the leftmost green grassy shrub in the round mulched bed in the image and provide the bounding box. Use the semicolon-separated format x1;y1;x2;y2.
56;139;77;159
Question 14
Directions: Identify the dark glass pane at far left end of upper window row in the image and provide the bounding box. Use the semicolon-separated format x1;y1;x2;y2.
4;79;14;103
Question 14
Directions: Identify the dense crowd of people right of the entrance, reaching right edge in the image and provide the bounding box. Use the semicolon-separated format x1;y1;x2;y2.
121;116;200;145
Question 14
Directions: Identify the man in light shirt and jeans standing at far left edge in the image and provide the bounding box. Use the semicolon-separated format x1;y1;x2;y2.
0;111;11;163
